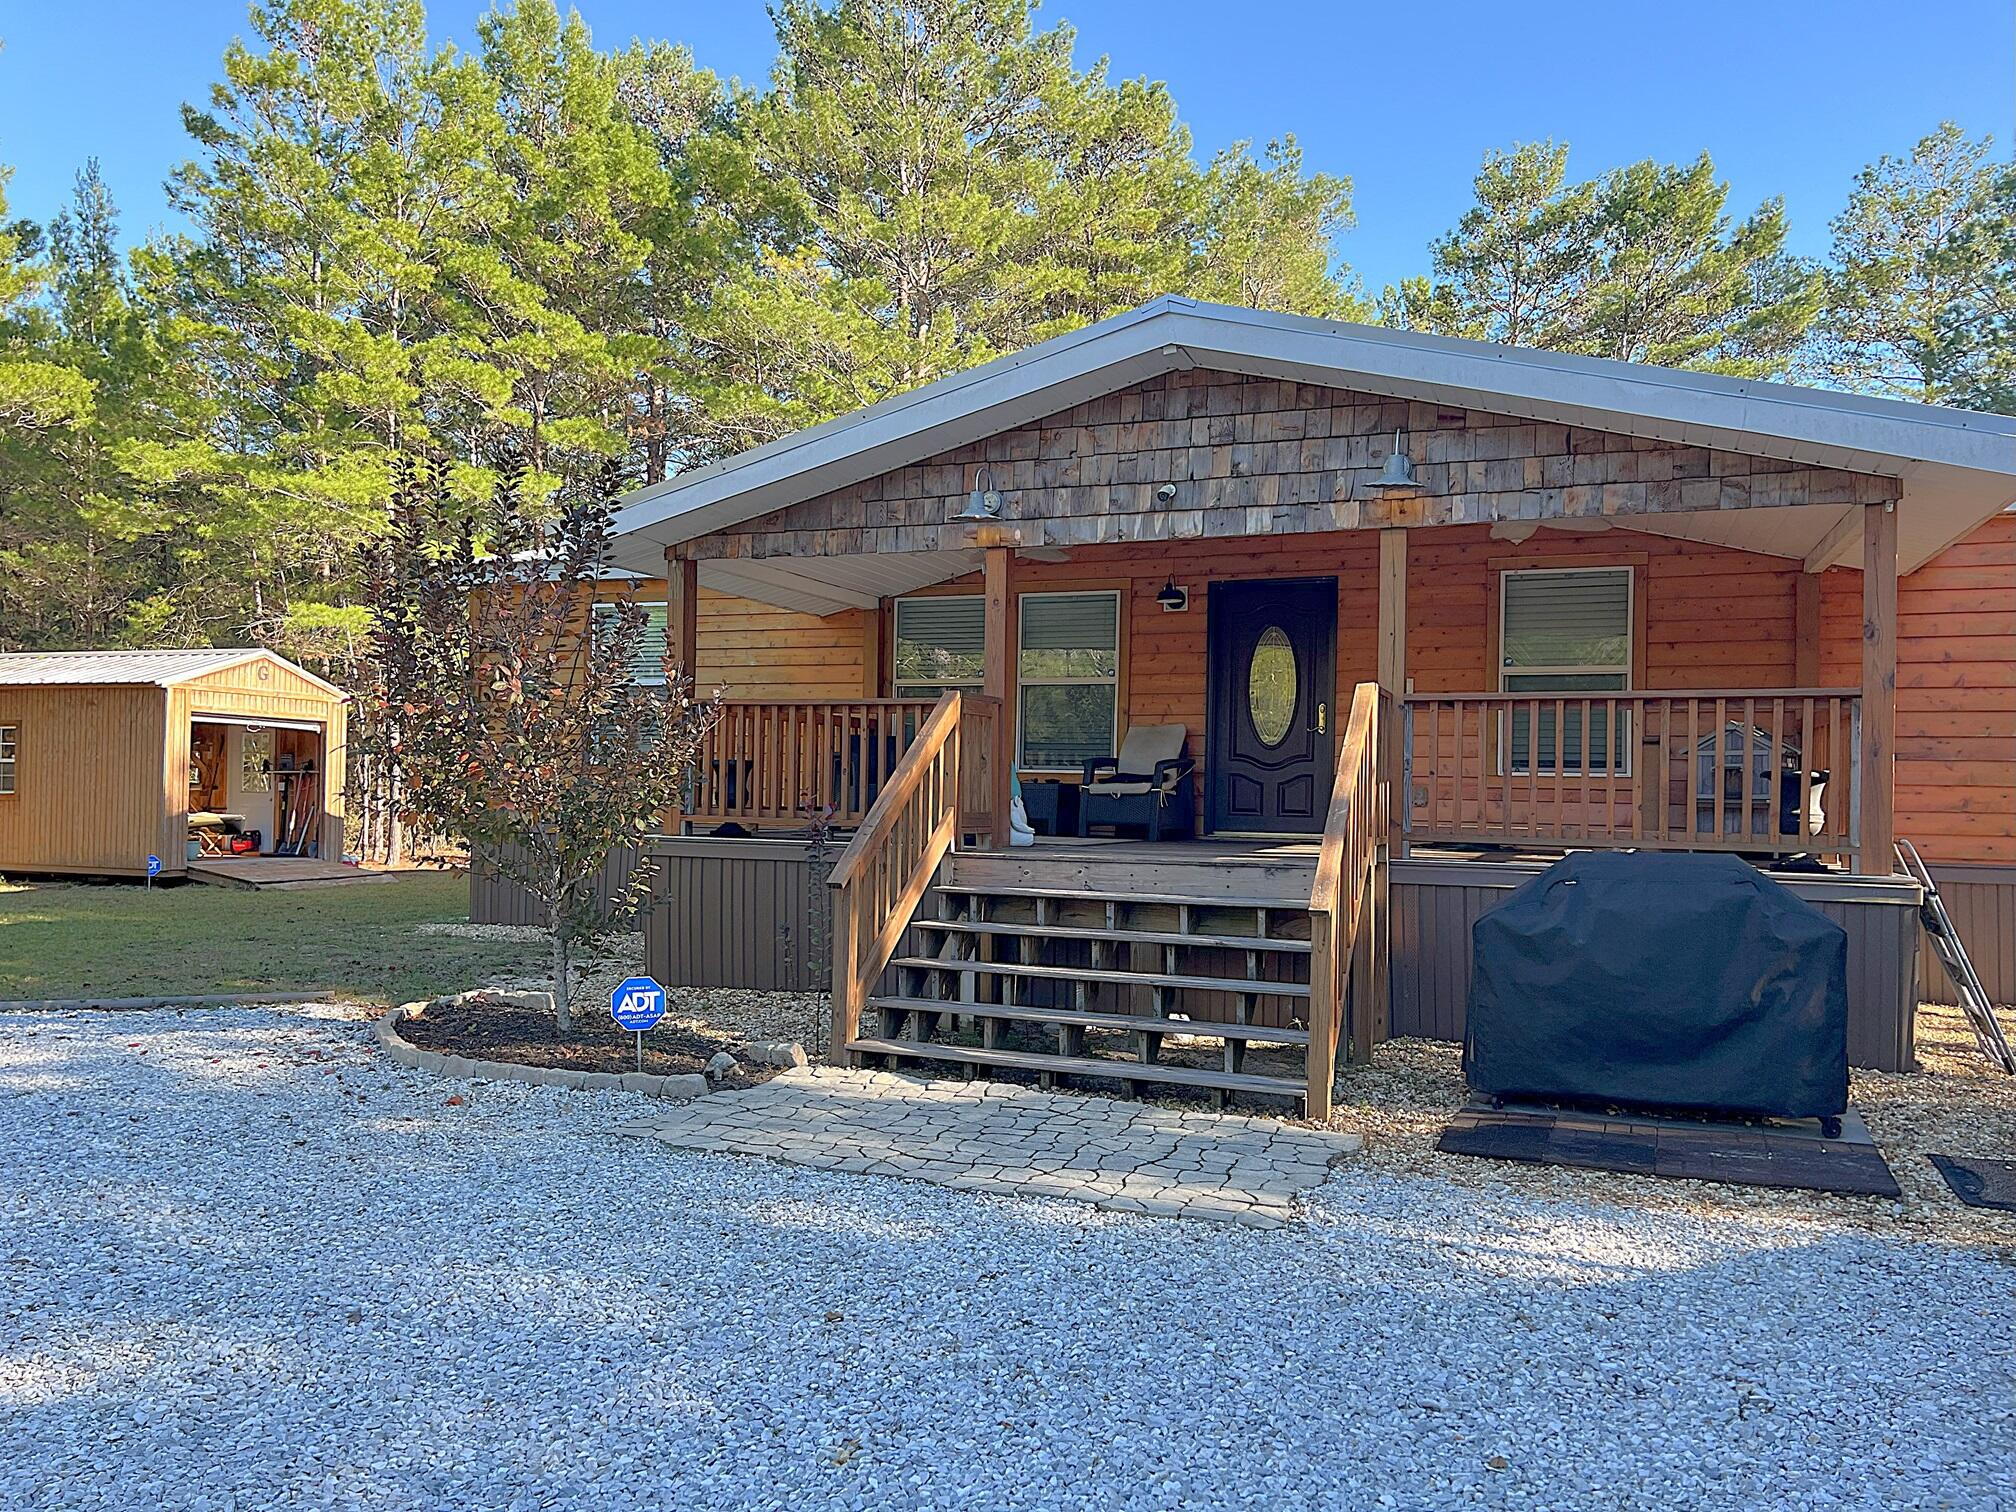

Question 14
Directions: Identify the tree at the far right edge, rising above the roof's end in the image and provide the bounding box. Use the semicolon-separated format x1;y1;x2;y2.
1808;121;2008;401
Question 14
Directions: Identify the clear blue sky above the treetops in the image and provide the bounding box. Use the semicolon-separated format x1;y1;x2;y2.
0;0;2016;288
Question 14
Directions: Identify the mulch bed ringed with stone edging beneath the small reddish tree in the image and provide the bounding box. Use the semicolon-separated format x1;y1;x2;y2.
399;1002;776;1087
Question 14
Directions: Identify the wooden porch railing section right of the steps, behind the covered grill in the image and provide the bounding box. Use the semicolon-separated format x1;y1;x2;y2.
1395;687;1861;859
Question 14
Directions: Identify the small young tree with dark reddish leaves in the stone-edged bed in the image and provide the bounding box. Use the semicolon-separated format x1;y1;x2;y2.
366;464;716;1034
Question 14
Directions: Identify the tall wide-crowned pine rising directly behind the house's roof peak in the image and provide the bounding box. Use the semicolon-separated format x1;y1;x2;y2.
679;0;1349;456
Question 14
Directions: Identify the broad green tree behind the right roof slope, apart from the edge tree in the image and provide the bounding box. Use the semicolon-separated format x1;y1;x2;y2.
1381;143;1820;377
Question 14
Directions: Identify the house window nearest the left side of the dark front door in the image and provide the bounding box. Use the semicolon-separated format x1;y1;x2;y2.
1016;593;1121;772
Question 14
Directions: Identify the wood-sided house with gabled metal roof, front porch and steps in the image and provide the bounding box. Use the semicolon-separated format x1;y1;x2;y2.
560;298;2016;1113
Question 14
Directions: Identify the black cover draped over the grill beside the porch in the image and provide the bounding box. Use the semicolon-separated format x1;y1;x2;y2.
1464;851;1849;1119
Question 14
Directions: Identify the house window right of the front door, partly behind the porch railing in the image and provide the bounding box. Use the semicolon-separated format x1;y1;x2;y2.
1498;566;1631;774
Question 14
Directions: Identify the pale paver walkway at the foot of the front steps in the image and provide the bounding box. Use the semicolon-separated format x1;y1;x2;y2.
619;1066;1363;1228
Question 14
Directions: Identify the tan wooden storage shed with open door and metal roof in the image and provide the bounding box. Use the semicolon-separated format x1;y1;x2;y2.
0;647;349;877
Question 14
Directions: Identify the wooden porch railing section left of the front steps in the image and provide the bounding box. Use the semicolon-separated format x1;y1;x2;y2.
683;698;1000;835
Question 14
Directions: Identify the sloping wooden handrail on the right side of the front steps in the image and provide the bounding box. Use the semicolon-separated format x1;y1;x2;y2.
1304;683;1385;1119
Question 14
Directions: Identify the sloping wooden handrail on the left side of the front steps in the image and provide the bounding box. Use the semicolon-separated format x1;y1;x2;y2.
827;691;962;1064
